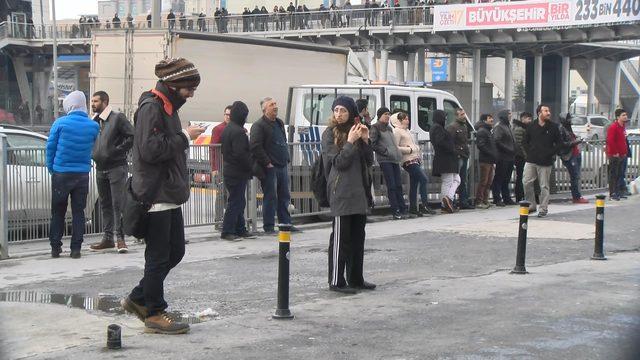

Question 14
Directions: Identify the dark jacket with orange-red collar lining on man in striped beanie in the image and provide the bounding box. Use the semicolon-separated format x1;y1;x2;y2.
131;82;189;205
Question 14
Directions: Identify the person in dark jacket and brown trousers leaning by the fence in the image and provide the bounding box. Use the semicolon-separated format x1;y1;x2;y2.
476;114;498;209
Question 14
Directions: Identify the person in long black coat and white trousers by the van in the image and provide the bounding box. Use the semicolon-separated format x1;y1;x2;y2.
429;110;460;213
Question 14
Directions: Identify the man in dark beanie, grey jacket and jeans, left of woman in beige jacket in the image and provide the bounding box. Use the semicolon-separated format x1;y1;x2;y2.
369;108;407;220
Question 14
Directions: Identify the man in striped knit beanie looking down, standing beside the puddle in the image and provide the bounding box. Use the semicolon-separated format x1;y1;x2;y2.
121;58;204;334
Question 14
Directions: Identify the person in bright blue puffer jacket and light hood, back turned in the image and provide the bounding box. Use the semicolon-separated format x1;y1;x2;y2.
47;91;100;259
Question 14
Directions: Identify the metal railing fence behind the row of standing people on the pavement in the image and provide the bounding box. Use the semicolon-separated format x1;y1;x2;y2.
0;136;640;250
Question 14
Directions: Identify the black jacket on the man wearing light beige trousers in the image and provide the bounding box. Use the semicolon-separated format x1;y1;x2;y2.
524;119;562;166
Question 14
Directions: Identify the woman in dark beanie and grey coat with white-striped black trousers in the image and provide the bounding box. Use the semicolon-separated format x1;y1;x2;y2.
322;96;376;294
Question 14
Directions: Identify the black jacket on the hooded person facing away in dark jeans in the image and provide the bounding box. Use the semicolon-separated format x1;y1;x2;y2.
221;121;251;182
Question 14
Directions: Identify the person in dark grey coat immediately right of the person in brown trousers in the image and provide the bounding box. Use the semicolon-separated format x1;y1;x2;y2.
491;110;516;206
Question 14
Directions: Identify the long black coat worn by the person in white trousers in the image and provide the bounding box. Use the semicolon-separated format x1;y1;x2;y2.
429;110;459;176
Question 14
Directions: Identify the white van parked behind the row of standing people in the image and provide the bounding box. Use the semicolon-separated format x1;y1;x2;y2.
285;85;473;142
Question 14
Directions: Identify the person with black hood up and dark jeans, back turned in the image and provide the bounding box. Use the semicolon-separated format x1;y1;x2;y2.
220;101;255;241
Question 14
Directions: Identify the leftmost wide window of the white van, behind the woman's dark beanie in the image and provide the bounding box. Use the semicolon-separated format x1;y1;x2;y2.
302;89;377;126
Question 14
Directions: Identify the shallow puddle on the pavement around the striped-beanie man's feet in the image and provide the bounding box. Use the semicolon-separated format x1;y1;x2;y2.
0;290;212;324
